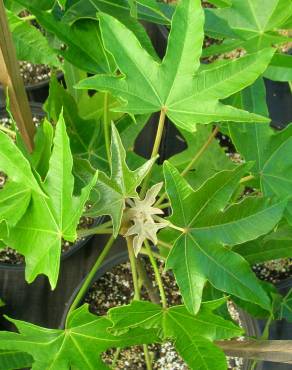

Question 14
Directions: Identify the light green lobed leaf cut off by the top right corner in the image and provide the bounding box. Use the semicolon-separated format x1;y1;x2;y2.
205;0;292;55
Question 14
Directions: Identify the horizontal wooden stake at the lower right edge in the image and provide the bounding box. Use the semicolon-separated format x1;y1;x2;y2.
215;340;292;364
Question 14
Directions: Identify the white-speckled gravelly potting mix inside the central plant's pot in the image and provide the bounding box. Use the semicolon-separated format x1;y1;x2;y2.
85;263;242;370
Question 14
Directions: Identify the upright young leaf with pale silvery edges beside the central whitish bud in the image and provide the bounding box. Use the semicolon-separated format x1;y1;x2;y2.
88;125;156;236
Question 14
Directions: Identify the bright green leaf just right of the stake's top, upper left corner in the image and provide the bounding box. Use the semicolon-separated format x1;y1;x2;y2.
6;10;61;68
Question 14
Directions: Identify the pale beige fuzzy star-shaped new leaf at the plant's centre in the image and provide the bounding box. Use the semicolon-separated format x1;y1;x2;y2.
125;182;169;256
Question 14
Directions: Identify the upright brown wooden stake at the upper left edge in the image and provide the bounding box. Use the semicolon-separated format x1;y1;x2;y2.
0;0;35;152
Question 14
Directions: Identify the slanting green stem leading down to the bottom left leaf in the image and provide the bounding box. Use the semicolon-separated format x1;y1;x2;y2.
66;236;115;325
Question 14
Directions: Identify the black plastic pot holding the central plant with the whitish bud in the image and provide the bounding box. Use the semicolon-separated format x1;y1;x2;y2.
59;246;263;370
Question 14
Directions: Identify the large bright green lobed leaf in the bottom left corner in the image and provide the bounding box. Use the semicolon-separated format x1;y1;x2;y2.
0;305;159;370
